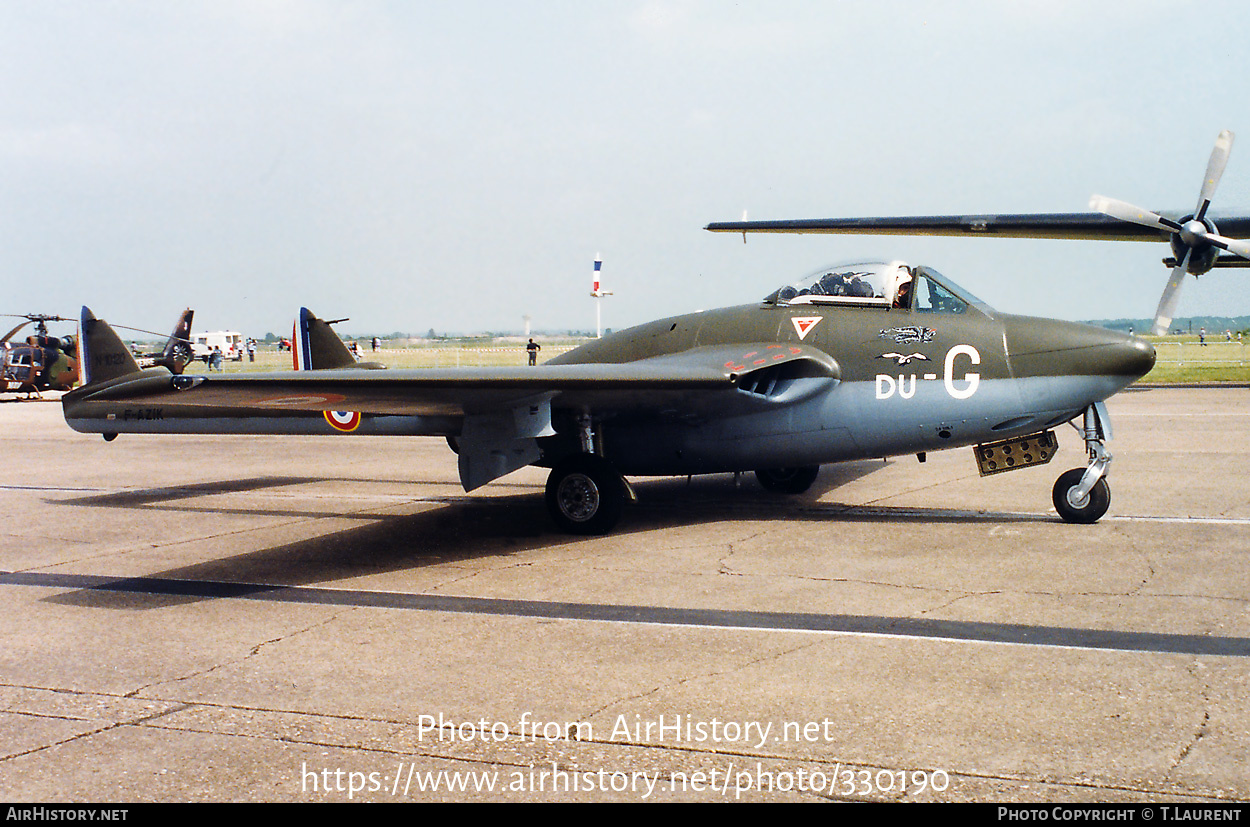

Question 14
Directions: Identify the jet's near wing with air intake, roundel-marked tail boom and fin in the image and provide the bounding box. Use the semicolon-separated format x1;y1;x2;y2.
61;307;840;490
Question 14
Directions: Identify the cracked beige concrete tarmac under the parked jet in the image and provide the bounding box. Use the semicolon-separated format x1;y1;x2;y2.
0;389;1250;803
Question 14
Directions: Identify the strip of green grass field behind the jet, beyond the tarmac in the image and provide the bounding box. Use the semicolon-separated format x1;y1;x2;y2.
188;336;1250;384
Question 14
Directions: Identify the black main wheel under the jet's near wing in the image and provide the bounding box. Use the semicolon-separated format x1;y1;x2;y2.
546;453;625;535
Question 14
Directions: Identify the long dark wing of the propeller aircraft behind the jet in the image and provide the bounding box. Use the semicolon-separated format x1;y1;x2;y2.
705;212;1250;241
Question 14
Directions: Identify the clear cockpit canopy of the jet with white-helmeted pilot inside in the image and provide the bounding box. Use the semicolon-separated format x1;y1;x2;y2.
764;261;990;314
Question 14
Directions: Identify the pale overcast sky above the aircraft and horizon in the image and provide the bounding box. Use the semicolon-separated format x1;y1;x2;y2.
0;0;1250;336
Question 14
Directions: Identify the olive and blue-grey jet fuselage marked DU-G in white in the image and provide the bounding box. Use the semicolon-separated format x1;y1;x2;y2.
553;279;1154;475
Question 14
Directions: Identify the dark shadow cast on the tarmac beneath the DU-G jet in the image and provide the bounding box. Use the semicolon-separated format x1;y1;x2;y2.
39;461;1058;610
